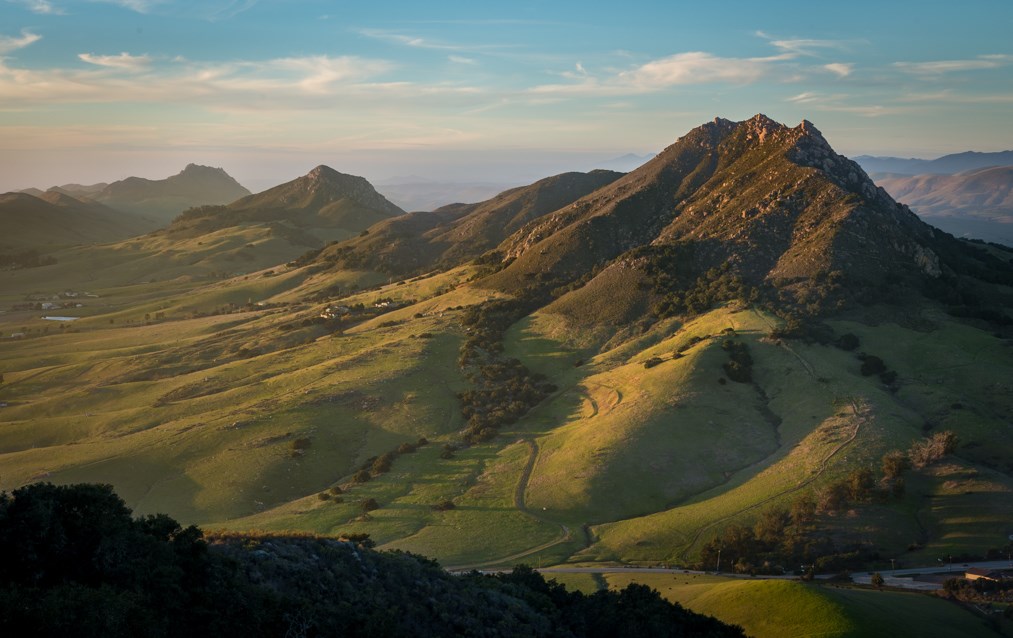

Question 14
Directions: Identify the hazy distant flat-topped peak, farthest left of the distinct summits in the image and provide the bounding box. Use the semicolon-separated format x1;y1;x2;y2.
95;164;250;224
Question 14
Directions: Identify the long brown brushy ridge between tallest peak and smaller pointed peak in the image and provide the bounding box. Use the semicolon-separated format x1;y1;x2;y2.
320;170;622;274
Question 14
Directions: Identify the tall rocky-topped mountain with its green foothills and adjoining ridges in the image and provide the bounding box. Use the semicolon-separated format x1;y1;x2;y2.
0;115;1013;603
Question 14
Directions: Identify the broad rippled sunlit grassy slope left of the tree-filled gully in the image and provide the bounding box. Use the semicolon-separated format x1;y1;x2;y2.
0;267;486;522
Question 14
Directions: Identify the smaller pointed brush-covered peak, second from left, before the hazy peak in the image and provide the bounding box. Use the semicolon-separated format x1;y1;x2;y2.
168;166;404;245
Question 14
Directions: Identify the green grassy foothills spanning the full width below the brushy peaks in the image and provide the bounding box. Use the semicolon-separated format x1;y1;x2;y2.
0;240;1013;563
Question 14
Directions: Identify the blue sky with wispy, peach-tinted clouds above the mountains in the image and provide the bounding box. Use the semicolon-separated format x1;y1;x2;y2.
0;0;1013;192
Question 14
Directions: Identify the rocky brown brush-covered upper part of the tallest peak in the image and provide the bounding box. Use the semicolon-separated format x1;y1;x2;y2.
489;115;950;299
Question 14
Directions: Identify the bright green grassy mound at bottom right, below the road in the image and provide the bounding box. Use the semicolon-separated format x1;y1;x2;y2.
606;574;996;638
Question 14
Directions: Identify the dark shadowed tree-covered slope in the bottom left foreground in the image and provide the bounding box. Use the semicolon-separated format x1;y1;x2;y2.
0;484;745;638
